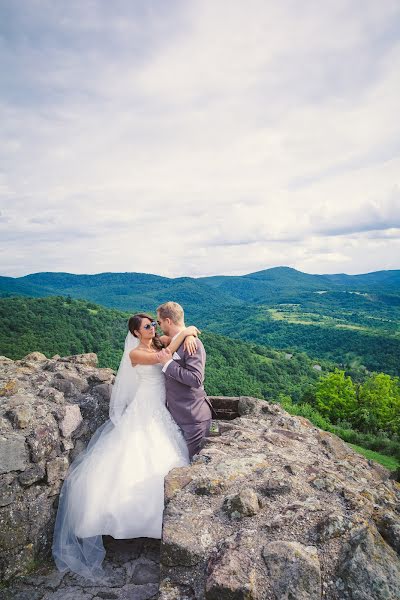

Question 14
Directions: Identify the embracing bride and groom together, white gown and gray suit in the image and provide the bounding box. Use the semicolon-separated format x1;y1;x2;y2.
53;302;211;579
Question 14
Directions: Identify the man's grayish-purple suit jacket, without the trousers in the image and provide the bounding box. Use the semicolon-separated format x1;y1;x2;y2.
165;339;211;425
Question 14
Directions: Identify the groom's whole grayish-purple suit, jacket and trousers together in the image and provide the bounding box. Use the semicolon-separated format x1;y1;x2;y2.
163;339;211;458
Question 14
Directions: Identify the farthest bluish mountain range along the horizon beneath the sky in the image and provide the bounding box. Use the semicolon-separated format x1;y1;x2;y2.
0;267;400;310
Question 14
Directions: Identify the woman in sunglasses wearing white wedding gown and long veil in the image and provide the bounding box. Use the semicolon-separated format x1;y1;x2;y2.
52;313;198;579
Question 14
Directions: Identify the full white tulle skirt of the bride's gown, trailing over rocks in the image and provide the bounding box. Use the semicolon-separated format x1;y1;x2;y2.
53;385;189;579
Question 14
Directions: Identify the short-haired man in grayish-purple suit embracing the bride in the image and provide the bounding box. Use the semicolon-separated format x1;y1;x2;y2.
157;302;211;458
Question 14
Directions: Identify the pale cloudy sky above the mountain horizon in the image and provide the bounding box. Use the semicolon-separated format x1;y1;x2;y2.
0;0;400;277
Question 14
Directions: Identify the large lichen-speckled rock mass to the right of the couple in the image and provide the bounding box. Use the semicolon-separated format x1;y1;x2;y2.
159;398;400;600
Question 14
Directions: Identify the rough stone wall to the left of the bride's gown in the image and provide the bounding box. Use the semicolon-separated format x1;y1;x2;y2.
0;352;114;580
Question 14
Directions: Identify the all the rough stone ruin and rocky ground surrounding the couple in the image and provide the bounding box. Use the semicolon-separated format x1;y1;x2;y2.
0;353;400;600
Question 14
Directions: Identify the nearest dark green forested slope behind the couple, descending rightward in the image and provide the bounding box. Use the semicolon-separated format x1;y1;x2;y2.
0;297;319;399
